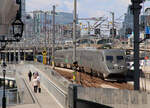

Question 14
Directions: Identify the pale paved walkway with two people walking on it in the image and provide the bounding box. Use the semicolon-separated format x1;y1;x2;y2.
9;64;61;108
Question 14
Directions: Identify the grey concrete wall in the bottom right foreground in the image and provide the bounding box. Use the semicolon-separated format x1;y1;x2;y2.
77;87;150;108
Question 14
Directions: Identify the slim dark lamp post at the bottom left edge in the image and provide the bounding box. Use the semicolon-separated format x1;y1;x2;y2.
2;61;7;108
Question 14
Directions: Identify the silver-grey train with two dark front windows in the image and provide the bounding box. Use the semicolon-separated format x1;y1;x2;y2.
55;49;127;78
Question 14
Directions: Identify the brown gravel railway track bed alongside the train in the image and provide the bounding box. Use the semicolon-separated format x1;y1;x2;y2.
55;67;133;90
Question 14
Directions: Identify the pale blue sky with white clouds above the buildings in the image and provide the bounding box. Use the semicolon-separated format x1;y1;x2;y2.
26;0;150;18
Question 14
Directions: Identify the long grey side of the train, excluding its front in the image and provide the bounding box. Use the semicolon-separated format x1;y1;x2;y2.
55;50;108;76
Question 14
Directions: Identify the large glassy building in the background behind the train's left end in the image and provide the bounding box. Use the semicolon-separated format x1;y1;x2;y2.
26;11;80;41
